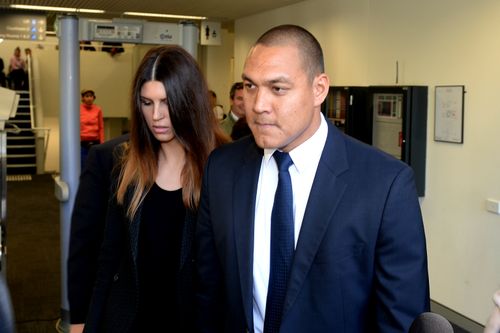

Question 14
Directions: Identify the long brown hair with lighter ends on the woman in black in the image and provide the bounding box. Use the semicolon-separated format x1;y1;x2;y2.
116;46;228;219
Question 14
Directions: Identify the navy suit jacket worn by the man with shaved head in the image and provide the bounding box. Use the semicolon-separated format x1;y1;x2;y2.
196;123;429;333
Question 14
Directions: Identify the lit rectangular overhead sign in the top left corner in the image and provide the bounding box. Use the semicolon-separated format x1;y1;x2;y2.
0;13;47;41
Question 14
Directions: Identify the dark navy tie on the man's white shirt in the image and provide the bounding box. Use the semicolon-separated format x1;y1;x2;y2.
264;150;295;333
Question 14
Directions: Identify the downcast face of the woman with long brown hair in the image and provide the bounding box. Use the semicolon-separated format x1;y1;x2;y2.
140;81;175;143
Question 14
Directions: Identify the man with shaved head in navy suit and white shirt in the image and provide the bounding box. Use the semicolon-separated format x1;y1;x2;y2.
196;25;429;333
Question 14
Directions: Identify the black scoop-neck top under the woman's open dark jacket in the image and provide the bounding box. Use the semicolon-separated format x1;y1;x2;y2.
134;183;186;332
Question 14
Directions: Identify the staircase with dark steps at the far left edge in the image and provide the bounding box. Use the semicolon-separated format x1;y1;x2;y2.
5;90;36;175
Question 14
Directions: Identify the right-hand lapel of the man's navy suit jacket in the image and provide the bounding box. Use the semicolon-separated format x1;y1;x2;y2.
283;122;348;317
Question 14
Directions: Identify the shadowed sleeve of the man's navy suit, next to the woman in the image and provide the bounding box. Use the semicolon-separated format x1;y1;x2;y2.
195;159;223;333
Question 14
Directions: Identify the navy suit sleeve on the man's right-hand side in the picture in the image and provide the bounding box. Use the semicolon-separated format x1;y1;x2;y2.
375;167;430;332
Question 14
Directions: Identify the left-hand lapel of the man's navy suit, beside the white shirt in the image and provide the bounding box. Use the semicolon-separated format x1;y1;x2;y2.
232;141;262;327
